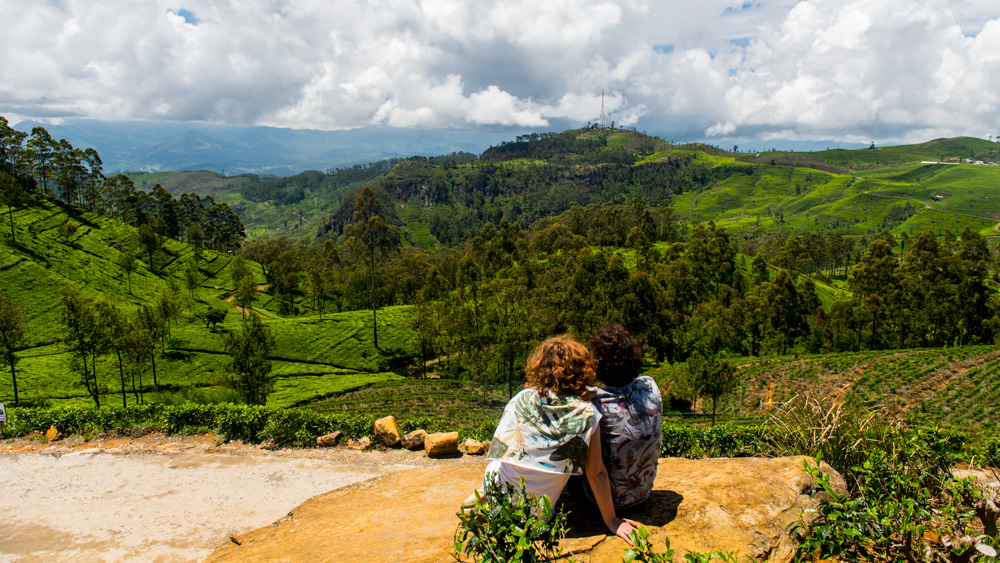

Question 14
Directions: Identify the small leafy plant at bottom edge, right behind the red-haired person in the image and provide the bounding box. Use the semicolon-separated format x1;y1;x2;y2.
452;478;568;562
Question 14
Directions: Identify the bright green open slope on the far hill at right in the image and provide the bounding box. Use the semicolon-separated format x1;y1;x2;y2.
664;148;1000;236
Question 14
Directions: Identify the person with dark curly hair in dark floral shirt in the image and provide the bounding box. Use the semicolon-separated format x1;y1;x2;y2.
574;325;663;510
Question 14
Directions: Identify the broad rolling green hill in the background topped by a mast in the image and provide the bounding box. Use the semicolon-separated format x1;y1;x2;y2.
121;129;1000;248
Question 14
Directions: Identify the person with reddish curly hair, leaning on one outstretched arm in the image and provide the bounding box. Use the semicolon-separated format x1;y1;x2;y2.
465;337;636;545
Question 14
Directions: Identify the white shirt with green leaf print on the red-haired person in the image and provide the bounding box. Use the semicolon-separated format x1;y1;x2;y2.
486;388;596;475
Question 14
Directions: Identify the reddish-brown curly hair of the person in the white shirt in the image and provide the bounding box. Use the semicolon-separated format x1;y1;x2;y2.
524;336;594;398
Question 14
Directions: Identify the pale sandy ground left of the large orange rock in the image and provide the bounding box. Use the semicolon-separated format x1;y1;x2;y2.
0;434;481;562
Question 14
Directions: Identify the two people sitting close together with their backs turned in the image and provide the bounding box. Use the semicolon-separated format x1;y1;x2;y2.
466;325;663;545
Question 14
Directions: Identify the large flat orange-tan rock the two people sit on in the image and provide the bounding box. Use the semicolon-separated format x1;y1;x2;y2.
206;457;846;563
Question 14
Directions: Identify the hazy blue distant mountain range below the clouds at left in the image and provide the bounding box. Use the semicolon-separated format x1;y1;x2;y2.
14;119;540;176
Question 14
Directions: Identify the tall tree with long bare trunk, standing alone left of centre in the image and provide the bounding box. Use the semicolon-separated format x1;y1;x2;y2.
347;186;396;348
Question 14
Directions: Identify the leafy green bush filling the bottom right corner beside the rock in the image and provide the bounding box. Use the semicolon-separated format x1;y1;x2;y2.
791;438;998;563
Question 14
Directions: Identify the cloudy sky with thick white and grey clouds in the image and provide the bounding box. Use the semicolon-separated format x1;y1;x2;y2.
0;0;1000;142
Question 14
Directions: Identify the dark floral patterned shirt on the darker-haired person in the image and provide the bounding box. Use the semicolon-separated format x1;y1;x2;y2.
585;376;663;508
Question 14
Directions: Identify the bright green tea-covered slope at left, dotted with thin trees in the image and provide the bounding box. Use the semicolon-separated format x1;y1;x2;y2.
0;202;411;406
